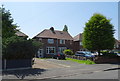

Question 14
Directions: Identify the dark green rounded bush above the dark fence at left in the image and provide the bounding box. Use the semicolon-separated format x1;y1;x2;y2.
3;36;41;59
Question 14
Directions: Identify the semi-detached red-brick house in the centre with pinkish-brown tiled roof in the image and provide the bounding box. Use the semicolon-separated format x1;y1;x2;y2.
33;27;73;57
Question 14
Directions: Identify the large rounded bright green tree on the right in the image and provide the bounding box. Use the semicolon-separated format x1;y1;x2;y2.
82;13;115;55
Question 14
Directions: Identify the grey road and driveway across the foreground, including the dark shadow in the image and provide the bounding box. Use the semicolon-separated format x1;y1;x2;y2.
3;59;120;79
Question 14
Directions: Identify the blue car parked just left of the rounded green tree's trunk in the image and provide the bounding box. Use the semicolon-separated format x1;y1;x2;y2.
75;51;95;58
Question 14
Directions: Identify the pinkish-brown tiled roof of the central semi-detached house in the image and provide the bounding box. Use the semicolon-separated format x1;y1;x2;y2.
35;29;73;40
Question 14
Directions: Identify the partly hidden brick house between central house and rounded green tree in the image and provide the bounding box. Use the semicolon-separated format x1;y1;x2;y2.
73;33;87;52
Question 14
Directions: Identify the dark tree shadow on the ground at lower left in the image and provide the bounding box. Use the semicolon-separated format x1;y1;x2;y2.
2;68;46;79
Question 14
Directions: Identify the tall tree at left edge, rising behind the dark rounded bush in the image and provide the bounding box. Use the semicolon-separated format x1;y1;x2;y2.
0;6;18;39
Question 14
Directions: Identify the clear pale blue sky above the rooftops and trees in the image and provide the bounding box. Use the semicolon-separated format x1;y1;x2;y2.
3;2;118;39
